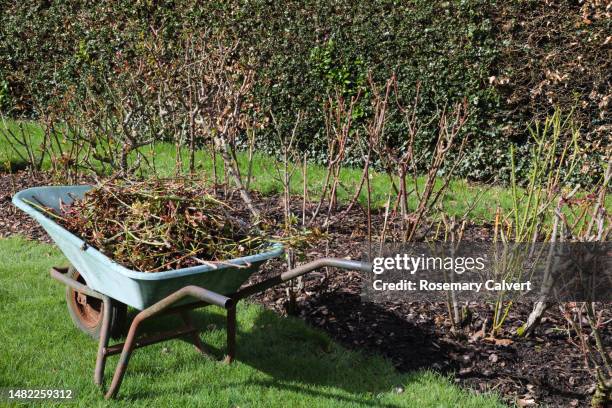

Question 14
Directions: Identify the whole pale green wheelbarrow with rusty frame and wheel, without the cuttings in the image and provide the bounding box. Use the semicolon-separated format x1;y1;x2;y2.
13;186;371;399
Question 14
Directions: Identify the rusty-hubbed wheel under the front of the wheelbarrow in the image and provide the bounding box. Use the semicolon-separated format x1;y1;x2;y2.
66;266;127;339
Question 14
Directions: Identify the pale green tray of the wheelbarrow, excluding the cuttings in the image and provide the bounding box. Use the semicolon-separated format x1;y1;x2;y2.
13;186;283;310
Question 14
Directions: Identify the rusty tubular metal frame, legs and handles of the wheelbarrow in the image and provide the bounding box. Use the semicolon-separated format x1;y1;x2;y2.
51;258;371;399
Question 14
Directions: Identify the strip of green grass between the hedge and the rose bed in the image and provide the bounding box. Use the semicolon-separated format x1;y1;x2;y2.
0;121;512;220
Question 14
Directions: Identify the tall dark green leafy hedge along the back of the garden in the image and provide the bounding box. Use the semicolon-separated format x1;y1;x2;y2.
0;0;611;180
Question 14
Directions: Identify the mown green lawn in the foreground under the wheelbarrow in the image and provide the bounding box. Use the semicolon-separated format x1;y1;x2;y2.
0;238;502;407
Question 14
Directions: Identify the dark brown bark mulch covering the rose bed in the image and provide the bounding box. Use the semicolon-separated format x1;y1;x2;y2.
0;173;612;407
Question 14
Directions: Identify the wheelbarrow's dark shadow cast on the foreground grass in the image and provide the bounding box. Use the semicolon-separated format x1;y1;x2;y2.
112;304;442;406
